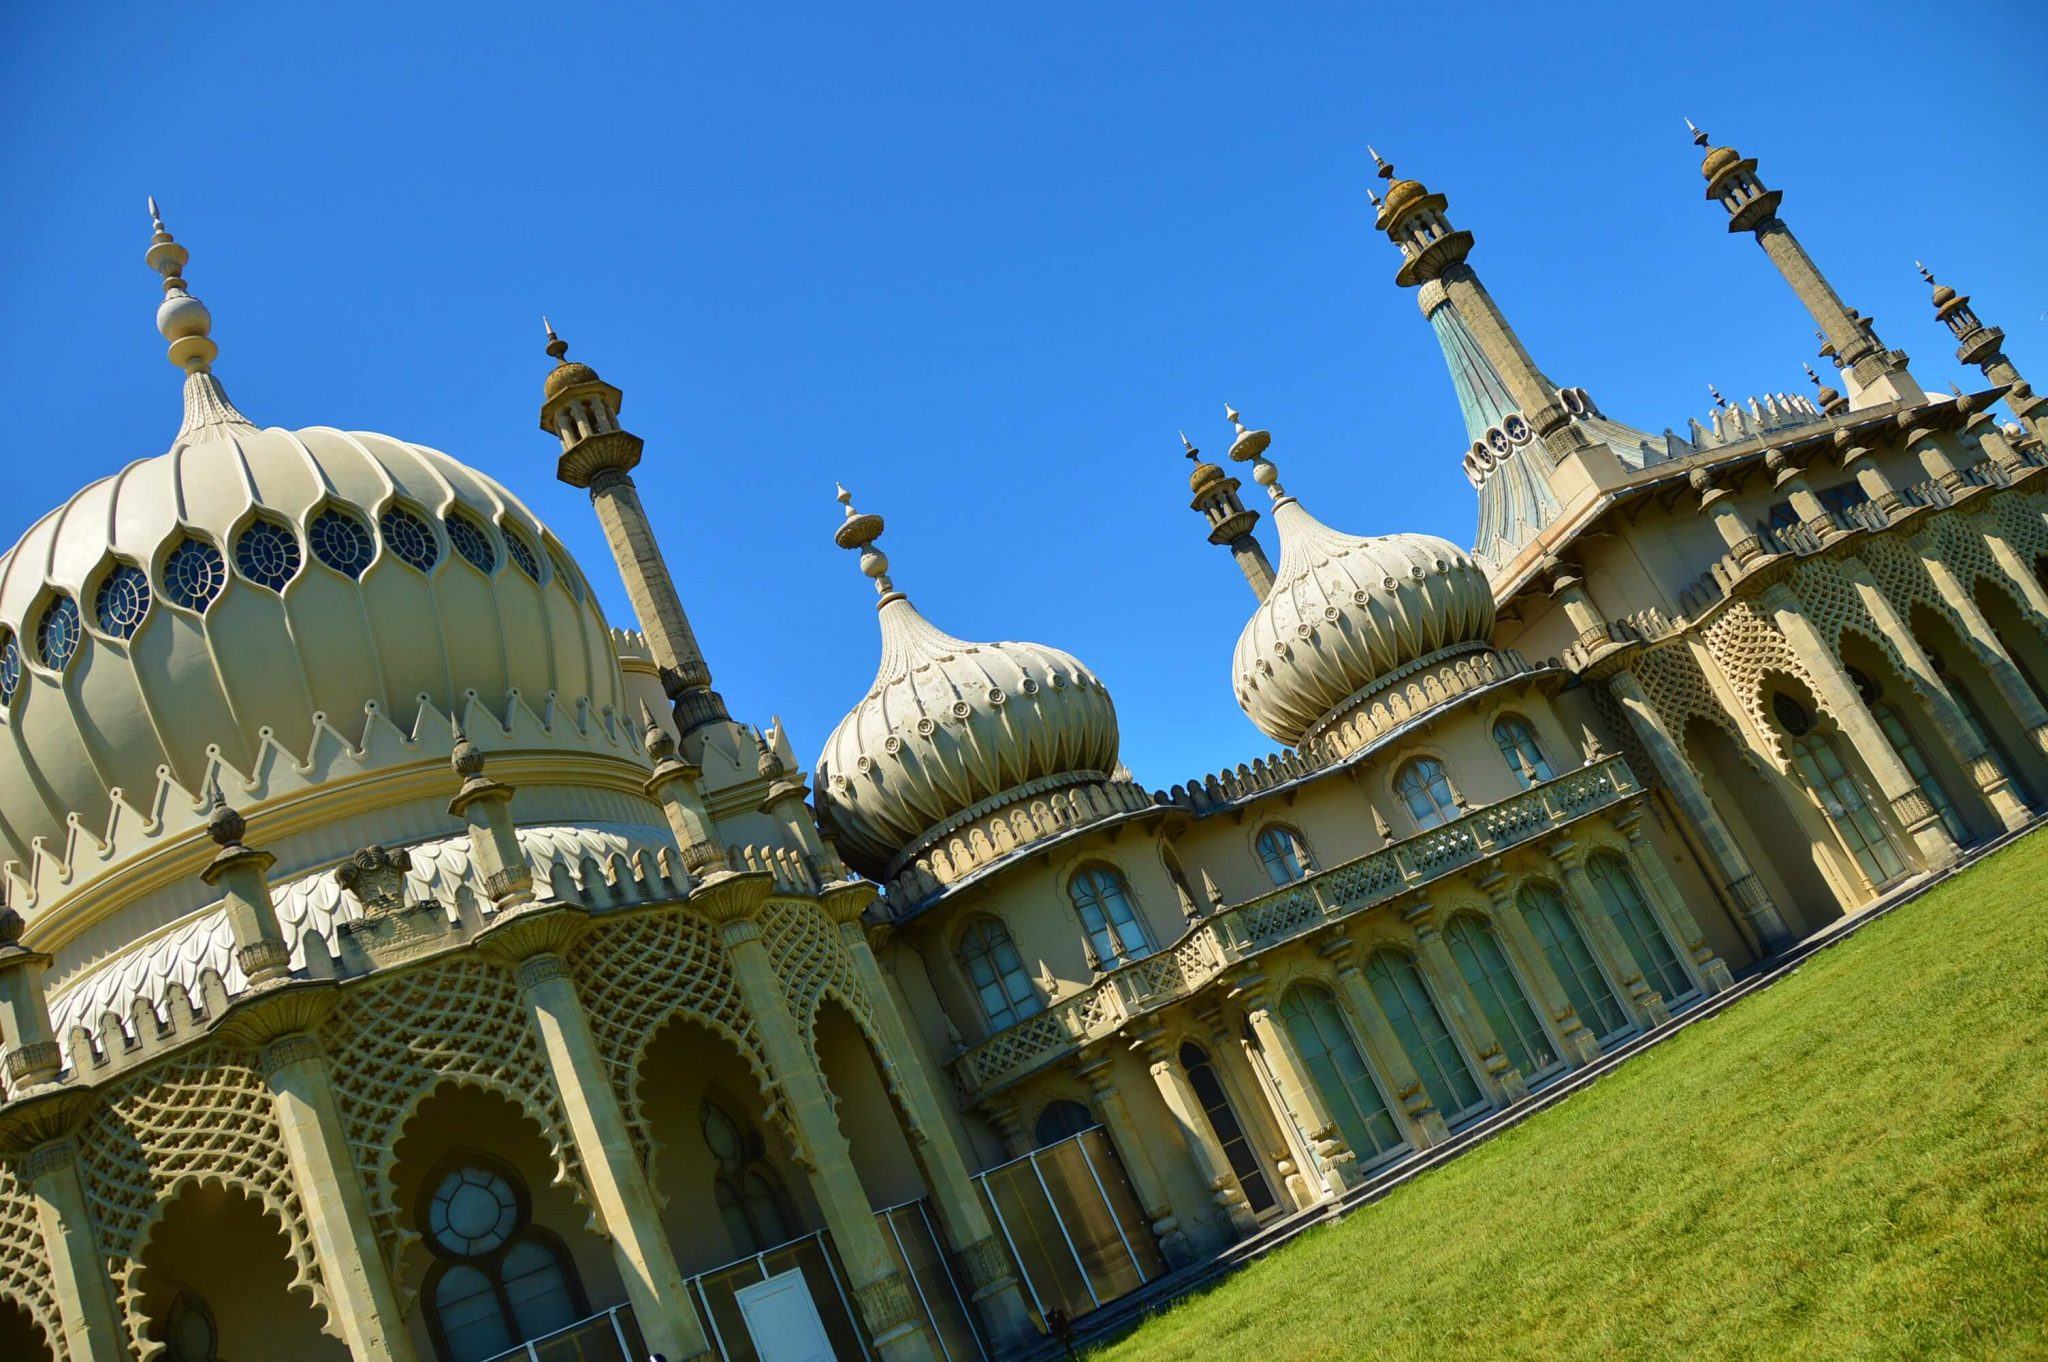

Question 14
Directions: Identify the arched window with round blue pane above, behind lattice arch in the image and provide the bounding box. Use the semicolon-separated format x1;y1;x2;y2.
420;1153;590;1362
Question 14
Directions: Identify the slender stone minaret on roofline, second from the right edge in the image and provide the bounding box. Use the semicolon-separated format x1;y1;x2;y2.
1686;119;1927;408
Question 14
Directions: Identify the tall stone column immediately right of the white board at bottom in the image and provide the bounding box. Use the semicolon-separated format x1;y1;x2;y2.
690;872;934;1362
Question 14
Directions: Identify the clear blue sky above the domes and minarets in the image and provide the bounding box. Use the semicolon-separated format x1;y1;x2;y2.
0;0;2048;786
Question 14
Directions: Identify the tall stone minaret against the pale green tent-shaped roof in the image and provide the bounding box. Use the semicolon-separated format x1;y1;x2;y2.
1366;147;1620;475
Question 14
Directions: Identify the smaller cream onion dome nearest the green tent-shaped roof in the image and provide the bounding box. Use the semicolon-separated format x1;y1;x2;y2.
1231;414;1493;748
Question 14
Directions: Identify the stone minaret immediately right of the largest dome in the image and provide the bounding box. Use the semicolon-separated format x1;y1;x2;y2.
541;317;729;733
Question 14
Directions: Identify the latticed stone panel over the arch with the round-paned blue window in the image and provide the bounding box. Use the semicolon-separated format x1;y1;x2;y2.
319;954;590;1272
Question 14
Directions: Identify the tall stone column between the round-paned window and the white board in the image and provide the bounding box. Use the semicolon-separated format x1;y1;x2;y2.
477;905;713;1360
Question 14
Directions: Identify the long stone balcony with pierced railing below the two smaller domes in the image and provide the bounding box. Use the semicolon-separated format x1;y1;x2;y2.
952;756;1642;1100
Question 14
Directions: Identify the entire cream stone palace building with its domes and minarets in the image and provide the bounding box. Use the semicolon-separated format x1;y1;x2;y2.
0;133;2048;1362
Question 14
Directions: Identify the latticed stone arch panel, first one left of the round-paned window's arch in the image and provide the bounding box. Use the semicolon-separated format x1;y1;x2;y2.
78;1047;328;1360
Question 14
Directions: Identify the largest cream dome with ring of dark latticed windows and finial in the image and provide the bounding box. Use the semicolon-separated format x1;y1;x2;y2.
0;203;623;862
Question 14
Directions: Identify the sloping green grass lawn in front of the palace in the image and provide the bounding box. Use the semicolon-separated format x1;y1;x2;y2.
1090;836;2048;1362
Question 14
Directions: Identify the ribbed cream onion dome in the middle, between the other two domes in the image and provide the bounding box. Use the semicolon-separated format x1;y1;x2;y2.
815;487;1116;879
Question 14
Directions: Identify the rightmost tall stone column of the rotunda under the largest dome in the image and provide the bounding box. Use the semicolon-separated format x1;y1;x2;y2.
819;881;1038;1346
